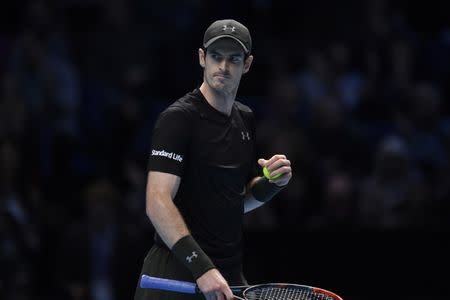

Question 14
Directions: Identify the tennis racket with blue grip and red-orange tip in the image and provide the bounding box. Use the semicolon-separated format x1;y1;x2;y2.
140;275;343;300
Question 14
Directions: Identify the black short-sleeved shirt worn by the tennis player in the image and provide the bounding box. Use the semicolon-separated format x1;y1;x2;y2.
148;89;259;269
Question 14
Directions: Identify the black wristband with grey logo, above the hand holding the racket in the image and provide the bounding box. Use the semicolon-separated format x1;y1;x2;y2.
172;235;215;280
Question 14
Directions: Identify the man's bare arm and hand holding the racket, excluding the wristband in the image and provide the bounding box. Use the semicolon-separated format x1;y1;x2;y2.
146;171;234;300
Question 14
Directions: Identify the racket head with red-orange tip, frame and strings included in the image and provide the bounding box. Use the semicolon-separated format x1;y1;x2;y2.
242;283;343;300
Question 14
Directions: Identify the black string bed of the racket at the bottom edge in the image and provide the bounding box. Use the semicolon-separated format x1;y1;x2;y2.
245;287;333;300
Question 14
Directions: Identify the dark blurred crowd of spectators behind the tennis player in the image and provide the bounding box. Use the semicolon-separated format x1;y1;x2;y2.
0;0;450;300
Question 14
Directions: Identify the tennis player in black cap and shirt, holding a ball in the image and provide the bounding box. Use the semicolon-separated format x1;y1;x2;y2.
134;20;292;300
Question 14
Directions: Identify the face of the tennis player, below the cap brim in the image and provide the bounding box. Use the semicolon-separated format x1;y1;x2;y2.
199;38;252;93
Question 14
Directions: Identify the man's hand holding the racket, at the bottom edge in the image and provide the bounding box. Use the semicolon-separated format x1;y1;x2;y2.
197;269;234;300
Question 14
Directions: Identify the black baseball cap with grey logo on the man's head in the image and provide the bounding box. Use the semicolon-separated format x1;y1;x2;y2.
203;19;252;54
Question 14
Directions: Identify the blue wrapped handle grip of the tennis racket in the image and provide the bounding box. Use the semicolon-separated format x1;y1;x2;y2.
140;275;199;294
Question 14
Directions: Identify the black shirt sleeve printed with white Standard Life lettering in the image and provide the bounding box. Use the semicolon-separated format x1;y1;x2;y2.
147;107;192;177
